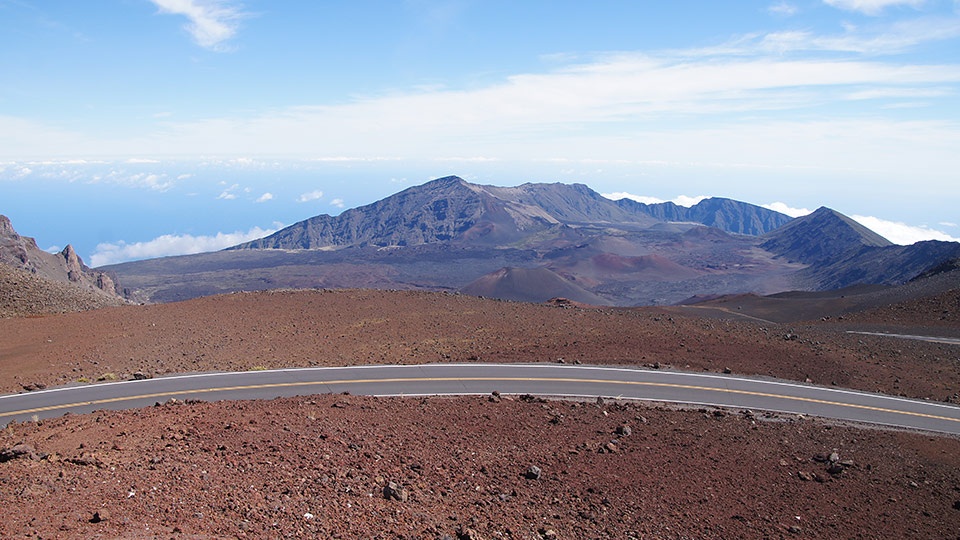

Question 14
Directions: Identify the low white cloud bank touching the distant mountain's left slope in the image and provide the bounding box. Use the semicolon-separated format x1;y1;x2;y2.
90;227;278;267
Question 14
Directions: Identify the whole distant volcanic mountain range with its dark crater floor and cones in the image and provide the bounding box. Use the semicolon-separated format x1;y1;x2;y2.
99;176;960;306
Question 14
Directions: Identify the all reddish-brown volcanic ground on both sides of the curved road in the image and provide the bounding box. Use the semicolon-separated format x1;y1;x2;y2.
0;290;960;539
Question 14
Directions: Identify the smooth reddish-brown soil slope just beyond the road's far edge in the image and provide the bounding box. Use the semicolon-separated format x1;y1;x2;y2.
7;290;960;400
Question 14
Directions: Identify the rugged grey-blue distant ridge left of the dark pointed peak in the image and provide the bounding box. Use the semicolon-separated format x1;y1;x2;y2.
227;176;790;250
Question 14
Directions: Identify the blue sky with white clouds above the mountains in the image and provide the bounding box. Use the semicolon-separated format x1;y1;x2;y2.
0;0;960;266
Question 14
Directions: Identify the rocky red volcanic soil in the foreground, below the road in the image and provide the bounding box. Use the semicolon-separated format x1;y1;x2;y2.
0;395;960;539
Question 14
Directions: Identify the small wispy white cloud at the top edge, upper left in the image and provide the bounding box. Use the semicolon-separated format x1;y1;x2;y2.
150;0;246;51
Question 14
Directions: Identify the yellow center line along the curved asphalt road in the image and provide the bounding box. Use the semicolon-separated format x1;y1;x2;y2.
0;377;960;422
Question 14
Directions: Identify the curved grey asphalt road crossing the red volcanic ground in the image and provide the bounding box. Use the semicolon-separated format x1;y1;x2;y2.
0;364;960;435
